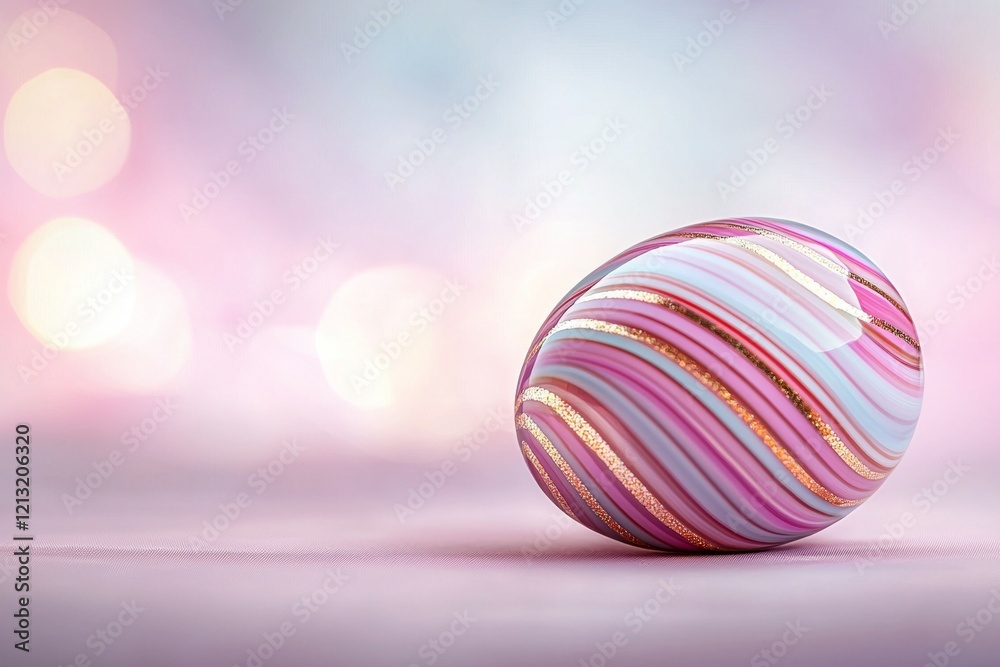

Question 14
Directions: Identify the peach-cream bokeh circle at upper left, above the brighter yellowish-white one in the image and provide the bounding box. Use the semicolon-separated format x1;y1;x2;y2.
4;67;131;198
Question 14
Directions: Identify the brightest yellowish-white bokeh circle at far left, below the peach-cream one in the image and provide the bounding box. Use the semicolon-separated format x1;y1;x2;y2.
8;218;136;350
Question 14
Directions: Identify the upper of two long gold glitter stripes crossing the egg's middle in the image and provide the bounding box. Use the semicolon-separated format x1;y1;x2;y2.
576;290;885;480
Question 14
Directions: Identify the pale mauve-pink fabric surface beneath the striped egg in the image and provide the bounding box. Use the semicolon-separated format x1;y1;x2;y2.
9;498;1000;667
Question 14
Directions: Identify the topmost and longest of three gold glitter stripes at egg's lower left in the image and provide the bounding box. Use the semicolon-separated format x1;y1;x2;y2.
518;387;719;551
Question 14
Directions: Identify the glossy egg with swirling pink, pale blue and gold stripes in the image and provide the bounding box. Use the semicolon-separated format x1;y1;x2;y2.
515;218;923;552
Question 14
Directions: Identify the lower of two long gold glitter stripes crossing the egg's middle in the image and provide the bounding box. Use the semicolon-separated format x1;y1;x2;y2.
522;320;862;507
